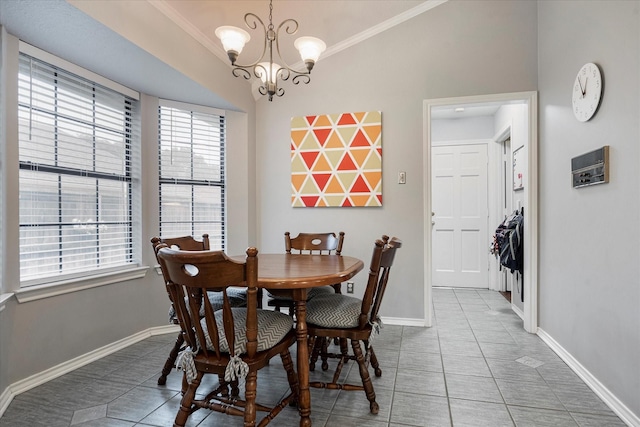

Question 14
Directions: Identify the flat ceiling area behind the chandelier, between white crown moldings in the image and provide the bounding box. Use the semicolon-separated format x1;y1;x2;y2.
152;0;436;68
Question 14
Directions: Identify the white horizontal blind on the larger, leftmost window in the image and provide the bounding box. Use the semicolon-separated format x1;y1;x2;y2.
18;53;140;286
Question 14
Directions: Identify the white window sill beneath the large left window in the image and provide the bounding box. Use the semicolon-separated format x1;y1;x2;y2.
15;266;149;304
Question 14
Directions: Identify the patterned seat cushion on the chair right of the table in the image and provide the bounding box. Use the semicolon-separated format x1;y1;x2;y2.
307;294;362;328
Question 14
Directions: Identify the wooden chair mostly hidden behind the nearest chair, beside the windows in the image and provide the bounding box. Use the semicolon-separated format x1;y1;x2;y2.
151;234;249;385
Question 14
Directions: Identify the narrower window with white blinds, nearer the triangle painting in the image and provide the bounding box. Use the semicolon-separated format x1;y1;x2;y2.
158;101;225;250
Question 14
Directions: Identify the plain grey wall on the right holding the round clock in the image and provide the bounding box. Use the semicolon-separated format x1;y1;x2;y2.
538;1;640;419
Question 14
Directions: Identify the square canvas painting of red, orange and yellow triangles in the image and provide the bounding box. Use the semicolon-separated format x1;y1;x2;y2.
290;111;382;207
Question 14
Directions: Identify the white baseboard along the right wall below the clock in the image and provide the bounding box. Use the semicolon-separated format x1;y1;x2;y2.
538;328;640;427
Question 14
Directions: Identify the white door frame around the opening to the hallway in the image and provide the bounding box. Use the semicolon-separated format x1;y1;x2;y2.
423;91;538;333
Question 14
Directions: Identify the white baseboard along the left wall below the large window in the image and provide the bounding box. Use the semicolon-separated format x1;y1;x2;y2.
0;325;180;417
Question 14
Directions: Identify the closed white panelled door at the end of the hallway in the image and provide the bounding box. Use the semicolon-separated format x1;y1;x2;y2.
431;144;491;289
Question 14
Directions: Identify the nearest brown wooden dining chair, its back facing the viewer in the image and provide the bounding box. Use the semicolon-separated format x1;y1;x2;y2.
158;245;299;427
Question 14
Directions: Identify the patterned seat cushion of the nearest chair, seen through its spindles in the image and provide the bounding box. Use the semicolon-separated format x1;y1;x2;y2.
200;307;293;356
